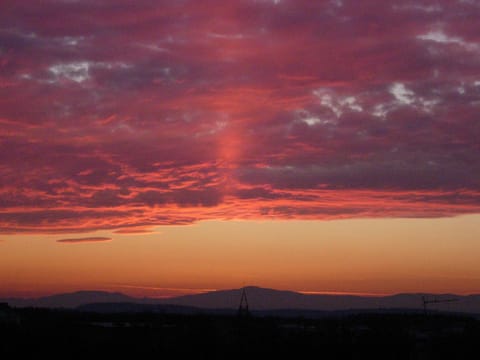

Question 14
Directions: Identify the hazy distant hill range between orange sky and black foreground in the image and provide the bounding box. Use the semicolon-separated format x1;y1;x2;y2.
0;286;480;313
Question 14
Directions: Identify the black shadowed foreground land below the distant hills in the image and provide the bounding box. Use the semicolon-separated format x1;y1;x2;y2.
0;308;480;360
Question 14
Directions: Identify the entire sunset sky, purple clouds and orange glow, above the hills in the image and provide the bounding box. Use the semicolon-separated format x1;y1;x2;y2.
0;0;480;297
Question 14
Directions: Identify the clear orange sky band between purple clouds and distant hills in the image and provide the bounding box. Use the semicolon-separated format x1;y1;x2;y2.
0;215;480;297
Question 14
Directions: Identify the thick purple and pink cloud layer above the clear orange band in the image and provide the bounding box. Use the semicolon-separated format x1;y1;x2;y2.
0;0;480;233
